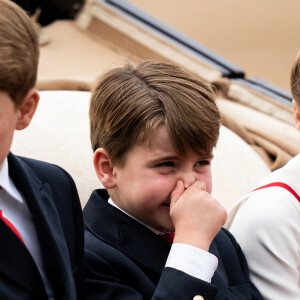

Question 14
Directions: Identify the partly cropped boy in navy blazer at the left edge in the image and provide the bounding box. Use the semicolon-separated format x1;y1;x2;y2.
0;0;85;300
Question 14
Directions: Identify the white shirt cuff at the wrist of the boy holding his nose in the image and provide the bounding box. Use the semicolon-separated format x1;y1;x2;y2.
165;243;218;283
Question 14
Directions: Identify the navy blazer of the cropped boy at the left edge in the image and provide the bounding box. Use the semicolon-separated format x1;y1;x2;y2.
0;153;85;300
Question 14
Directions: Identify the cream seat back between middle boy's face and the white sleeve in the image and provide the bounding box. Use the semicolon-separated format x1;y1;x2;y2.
212;126;270;210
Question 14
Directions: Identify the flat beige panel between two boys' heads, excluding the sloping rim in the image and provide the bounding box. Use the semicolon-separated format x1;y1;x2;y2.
37;21;121;90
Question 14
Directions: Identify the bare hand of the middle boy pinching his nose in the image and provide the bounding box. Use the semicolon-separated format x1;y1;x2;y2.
170;180;227;251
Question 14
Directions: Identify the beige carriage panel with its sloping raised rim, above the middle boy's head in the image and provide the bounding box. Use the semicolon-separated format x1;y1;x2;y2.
37;1;222;90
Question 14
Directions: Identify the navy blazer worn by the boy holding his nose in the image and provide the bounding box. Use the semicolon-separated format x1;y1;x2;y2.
83;190;262;300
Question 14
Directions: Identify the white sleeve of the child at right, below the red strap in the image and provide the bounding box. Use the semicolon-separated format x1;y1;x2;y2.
230;187;300;300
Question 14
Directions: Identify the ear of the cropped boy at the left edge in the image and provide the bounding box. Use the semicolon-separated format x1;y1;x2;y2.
16;89;40;130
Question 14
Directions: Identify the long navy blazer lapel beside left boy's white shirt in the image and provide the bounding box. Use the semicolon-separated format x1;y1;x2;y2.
8;154;76;299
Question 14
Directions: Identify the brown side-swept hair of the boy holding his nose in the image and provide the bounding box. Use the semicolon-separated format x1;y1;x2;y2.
89;61;221;164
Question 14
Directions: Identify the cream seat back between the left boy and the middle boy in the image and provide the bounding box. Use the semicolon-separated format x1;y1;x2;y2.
12;91;101;206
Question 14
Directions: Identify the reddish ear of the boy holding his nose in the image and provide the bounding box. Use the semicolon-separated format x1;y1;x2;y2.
94;148;116;189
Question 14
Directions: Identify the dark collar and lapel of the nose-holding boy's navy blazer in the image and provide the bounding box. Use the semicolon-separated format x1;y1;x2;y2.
83;190;171;274
